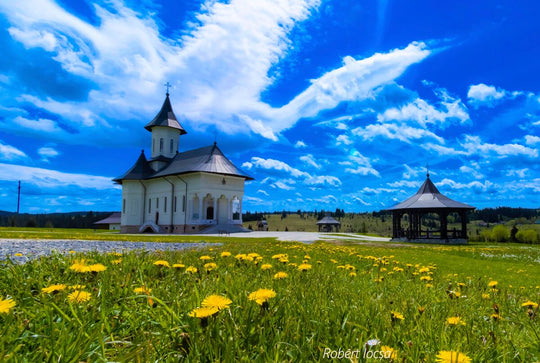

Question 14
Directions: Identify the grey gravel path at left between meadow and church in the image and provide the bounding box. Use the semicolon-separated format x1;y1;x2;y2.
0;239;215;262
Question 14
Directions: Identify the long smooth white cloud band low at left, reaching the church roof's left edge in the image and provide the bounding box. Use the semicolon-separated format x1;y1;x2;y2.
0;163;120;190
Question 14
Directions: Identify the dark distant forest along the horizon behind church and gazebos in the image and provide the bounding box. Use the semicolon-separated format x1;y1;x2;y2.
0;207;540;228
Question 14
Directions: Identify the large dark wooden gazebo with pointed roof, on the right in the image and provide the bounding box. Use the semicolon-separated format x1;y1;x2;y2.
386;173;475;244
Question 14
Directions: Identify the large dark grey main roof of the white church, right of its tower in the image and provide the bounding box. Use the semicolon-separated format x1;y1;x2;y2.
149;143;253;180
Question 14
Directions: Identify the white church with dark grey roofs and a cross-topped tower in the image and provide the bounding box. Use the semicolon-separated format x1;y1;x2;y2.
114;92;253;233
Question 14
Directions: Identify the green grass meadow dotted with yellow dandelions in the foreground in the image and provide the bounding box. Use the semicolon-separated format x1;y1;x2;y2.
0;236;540;362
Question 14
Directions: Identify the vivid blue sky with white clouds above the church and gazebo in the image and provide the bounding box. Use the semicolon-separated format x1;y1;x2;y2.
0;0;540;213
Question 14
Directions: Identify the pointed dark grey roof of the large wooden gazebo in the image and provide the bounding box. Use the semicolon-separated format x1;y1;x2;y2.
386;174;475;211
